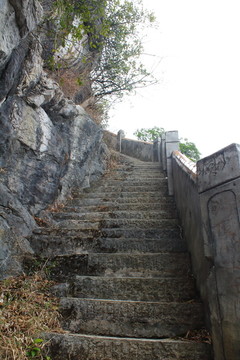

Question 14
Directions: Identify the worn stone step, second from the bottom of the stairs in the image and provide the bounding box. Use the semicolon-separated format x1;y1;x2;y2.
60;298;204;338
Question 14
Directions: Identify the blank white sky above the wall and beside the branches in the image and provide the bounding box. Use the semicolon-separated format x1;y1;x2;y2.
108;0;240;157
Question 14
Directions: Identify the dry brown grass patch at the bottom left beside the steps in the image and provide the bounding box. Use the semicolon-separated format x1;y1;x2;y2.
0;273;63;360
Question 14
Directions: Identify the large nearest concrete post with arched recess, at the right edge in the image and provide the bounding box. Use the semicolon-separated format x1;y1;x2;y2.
197;144;240;360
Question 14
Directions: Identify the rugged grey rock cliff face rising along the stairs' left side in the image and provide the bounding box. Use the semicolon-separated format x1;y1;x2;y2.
0;0;108;277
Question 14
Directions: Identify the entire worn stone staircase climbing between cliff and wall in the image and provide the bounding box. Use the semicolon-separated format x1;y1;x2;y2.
29;156;211;360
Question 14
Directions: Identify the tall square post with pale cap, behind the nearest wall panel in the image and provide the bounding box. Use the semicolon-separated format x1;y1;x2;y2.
165;131;179;195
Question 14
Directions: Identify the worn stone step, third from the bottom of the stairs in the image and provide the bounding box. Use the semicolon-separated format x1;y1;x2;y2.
52;276;196;302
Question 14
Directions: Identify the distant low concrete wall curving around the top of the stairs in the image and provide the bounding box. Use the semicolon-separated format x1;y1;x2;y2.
104;131;153;161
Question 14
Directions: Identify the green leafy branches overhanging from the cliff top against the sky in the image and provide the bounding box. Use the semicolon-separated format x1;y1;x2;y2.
45;0;157;98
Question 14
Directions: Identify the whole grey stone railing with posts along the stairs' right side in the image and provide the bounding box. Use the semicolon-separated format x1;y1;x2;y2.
158;132;240;360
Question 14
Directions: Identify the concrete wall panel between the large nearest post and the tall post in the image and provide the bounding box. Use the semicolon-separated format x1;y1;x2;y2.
172;152;211;327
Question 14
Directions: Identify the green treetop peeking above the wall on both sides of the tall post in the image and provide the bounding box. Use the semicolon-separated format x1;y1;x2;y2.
133;126;201;162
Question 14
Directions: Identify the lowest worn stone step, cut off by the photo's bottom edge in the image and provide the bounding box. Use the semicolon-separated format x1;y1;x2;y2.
45;333;212;360
